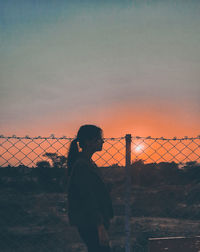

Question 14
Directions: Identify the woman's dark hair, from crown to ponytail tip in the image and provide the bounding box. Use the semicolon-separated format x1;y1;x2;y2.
67;124;102;176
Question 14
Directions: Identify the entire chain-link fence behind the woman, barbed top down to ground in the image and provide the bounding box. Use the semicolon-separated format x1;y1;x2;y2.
0;134;200;252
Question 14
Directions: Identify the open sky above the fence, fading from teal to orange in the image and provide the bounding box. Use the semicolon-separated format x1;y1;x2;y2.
0;0;200;137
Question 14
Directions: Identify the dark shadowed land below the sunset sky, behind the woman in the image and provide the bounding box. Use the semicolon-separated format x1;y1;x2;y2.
0;163;200;252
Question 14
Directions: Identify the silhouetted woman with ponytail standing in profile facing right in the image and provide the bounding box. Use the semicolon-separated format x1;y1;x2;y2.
67;125;113;252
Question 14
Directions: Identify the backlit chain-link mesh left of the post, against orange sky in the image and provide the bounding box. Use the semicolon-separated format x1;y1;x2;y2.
0;135;125;167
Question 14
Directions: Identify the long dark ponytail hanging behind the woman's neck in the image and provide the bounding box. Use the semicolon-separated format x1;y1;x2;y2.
67;138;79;176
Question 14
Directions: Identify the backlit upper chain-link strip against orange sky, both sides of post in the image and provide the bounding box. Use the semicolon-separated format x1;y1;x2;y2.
0;134;200;167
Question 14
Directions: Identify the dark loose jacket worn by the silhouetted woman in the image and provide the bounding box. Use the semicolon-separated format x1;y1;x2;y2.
68;157;113;229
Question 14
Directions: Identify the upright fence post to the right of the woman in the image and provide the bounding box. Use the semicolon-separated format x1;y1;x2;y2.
125;134;131;252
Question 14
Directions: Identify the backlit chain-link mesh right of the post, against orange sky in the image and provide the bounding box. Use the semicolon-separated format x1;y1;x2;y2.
132;136;200;163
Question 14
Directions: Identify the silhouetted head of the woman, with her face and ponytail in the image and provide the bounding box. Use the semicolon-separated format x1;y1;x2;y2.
67;124;103;175
